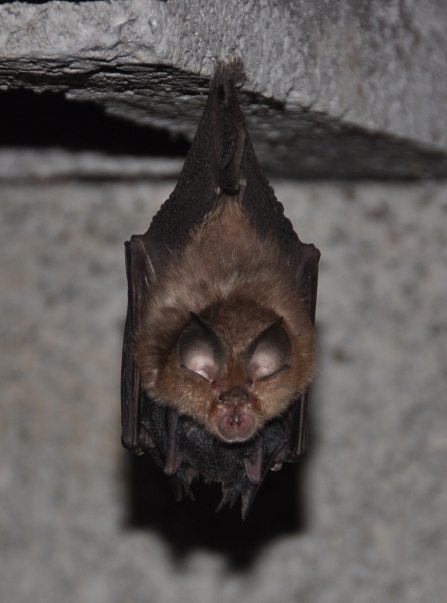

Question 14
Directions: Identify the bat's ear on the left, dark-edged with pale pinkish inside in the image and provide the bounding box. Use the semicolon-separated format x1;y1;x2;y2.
177;312;225;381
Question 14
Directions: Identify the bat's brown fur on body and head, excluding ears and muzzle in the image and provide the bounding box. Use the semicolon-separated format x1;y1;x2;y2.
135;198;315;437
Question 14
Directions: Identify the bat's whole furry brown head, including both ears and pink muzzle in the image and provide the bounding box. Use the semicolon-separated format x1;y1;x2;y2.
146;304;313;442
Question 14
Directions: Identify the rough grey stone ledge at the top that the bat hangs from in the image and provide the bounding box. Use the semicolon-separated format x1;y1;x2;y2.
0;0;447;178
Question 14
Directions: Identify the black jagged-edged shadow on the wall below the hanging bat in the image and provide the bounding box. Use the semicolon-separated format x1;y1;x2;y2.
126;453;307;571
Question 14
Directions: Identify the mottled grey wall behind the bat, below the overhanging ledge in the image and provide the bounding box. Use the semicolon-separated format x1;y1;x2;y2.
0;181;447;603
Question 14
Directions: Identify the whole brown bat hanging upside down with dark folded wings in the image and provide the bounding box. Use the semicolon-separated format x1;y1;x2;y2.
121;58;320;519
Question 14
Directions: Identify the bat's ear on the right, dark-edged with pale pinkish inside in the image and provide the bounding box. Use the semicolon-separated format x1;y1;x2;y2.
245;318;291;381
